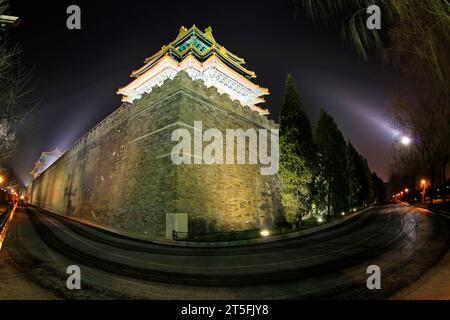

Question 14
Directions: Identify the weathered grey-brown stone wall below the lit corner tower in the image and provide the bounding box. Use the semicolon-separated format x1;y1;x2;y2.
31;72;283;239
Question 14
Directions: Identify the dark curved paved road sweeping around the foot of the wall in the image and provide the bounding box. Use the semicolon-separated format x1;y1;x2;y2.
0;203;450;299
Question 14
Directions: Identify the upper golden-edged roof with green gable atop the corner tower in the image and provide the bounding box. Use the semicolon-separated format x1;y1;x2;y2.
131;25;256;79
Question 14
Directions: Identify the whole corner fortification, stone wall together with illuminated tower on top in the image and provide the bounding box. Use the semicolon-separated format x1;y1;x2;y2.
30;26;283;239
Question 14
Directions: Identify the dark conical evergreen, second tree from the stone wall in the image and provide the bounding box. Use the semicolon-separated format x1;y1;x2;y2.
315;110;349;216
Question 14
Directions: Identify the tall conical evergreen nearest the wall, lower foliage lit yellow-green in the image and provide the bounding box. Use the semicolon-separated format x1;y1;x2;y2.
280;75;316;225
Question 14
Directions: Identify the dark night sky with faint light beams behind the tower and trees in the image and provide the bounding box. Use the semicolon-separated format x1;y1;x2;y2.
10;0;400;182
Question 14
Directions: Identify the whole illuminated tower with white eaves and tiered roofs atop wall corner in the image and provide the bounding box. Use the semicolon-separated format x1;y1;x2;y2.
118;25;269;115
